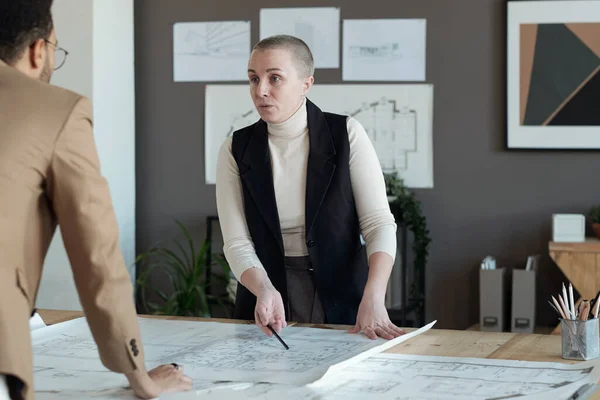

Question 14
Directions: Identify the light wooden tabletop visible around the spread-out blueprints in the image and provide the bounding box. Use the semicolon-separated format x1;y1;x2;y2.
38;310;600;400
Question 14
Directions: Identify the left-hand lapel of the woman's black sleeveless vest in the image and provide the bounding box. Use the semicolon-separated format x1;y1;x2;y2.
240;120;284;254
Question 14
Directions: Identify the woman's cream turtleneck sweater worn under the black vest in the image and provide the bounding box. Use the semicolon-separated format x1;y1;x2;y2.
216;101;396;280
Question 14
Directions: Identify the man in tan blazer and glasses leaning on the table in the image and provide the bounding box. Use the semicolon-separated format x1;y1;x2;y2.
0;0;192;399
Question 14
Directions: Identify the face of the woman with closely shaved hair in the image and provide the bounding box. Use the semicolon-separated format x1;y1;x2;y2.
248;49;314;123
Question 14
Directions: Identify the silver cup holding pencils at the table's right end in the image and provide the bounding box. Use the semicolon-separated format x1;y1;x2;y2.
560;318;600;361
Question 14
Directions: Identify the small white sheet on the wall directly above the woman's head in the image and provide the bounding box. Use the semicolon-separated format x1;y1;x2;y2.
260;7;340;68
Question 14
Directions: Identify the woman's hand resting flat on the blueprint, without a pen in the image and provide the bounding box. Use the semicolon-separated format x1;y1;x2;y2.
348;293;406;340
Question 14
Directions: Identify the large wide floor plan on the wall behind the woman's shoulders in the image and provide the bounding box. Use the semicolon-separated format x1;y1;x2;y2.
204;84;433;188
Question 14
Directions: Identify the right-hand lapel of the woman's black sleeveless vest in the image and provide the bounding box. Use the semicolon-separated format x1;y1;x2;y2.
305;99;335;236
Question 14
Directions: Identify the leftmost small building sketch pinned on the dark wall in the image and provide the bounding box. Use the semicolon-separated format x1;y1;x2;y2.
173;21;250;82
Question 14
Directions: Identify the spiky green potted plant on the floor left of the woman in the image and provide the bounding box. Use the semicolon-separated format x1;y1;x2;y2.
135;221;232;318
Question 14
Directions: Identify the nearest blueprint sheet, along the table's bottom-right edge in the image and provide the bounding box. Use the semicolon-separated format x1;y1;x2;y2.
189;353;600;400
